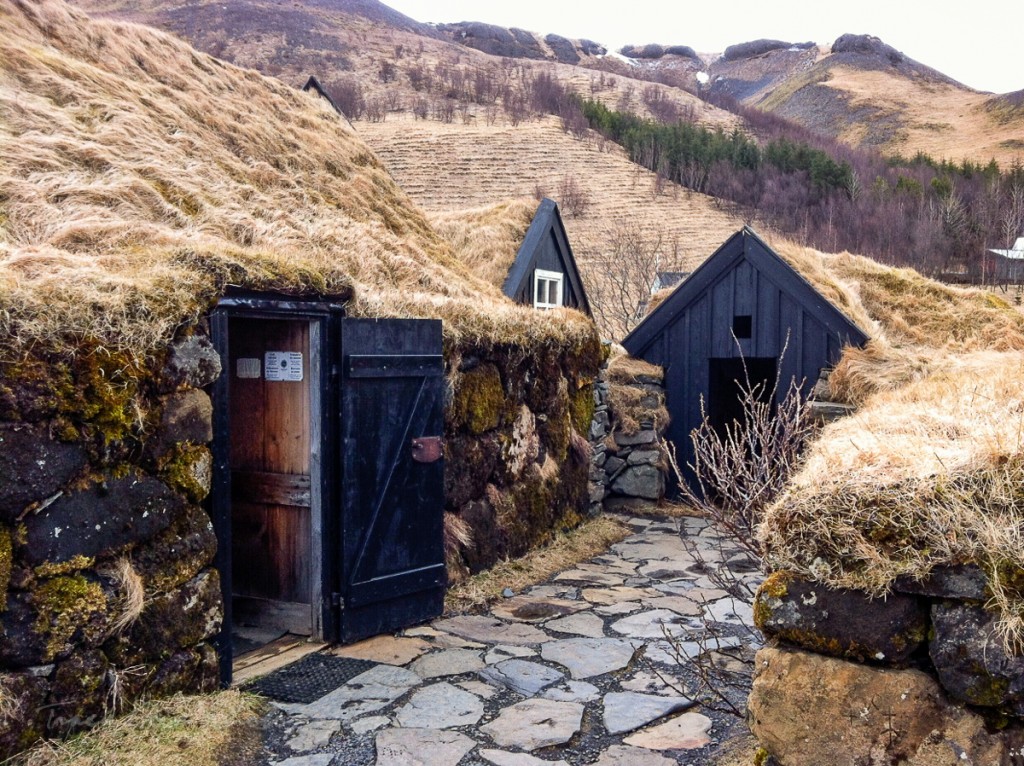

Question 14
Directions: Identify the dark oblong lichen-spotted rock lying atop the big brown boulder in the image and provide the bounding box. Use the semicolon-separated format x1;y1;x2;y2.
754;572;928;665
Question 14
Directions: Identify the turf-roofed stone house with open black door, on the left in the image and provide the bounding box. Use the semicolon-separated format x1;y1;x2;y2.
0;1;601;753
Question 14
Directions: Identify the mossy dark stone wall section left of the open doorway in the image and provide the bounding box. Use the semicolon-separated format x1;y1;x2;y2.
0;331;222;758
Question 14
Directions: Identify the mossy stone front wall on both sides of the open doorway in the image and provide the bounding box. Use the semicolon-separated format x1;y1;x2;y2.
0;325;602;760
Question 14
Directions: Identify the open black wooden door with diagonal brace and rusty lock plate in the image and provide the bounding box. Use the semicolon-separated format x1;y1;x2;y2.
339;318;445;642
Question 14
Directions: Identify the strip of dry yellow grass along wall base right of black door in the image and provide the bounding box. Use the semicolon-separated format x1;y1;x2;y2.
444;515;630;614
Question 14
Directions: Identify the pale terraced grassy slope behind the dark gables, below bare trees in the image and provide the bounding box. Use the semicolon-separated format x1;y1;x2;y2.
356;116;743;268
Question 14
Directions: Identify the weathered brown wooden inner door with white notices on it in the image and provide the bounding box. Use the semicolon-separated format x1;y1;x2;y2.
226;318;312;634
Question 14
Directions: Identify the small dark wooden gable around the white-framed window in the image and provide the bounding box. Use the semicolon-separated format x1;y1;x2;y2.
502;199;592;315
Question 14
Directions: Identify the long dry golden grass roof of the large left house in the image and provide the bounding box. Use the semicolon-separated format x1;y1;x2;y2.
0;0;593;356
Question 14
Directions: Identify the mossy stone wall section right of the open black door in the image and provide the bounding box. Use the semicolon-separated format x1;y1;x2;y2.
444;334;603;582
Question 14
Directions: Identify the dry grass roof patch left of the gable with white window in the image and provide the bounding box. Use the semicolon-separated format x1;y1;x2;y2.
430;198;537;290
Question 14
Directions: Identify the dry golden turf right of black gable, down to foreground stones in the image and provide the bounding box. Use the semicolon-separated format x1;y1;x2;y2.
760;236;1024;647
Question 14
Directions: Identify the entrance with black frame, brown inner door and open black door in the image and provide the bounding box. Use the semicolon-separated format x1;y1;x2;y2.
210;294;446;683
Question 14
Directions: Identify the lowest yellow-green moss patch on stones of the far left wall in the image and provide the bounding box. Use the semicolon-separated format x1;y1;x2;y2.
32;575;108;662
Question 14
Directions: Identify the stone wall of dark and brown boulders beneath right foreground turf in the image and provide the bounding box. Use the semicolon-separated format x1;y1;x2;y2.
750;565;1024;766
